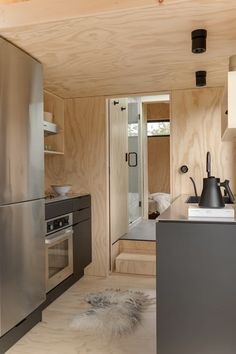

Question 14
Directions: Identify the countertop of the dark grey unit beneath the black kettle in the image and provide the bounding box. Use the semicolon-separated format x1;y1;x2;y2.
156;194;236;223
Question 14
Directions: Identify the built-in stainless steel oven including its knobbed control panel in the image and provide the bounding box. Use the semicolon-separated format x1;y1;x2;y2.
45;214;73;292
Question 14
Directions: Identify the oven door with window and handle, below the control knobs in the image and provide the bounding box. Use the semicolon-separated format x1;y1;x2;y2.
45;227;73;292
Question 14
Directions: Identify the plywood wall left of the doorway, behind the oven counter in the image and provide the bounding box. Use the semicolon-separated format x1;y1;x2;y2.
45;97;109;276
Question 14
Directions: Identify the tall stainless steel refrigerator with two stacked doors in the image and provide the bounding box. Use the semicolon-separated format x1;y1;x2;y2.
0;38;45;336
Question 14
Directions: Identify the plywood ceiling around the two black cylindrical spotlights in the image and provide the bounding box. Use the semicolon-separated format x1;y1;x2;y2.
0;0;236;98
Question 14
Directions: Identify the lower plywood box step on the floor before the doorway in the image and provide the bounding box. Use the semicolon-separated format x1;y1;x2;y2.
116;252;156;275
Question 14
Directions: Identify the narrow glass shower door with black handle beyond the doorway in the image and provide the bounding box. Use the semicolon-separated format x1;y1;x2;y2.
127;98;142;224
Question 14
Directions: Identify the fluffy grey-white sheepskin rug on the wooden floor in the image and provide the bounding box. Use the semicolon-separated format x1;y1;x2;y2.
70;289;155;336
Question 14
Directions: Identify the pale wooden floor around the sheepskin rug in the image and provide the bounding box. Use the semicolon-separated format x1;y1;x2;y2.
7;274;156;354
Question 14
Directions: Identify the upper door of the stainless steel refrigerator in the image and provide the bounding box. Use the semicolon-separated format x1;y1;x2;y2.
0;39;44;205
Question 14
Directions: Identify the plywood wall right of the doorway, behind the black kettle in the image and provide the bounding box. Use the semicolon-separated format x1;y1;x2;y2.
171;88;236;198
